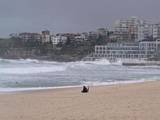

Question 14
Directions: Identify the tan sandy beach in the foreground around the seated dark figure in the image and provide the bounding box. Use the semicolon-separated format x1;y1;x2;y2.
0;81;160;120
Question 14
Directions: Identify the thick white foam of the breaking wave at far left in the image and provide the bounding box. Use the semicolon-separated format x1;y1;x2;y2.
0;59;66;74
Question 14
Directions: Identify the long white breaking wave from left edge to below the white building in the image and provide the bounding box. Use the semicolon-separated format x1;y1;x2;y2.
0;59;121;74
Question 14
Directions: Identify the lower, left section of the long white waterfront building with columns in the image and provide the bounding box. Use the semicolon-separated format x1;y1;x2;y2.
95;43;139;60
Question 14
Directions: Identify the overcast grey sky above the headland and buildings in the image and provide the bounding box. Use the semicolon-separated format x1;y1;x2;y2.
0;0;160;37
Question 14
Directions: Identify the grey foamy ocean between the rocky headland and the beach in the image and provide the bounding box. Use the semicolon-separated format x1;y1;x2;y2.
0;59;160;92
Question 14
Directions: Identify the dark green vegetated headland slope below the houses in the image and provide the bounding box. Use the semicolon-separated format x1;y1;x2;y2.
0;35;107;61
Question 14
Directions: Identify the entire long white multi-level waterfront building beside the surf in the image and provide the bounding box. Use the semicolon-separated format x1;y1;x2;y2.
95;41;160;59
